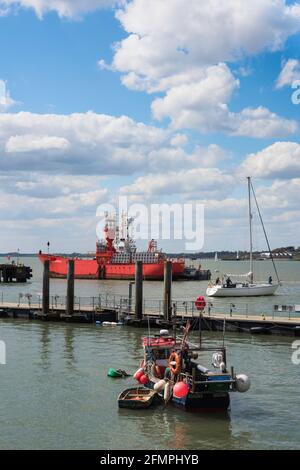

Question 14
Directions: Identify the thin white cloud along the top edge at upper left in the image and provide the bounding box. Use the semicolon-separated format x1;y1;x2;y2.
0;0;117;18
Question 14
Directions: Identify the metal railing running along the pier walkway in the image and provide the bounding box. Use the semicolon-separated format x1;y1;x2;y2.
0;292;299;319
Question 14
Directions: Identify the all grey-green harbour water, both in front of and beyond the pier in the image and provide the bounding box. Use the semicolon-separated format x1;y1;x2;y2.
0;258;300;449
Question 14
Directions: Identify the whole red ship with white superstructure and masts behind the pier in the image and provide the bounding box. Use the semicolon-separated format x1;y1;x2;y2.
39;216;185;280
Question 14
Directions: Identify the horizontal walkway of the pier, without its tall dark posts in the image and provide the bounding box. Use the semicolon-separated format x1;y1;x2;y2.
0;296;300;336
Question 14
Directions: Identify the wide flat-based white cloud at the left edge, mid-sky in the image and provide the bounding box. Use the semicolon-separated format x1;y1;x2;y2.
0;112;174;175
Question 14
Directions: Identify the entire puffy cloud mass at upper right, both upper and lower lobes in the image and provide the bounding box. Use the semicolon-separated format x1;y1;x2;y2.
108;0;300;138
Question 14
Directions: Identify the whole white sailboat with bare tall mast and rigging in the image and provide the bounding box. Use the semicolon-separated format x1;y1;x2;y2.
206;177;280;297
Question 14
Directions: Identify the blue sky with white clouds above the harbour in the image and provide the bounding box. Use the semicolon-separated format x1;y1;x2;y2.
0;0;300;252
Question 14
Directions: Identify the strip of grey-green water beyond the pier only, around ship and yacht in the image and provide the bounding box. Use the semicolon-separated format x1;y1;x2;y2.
0;258;300;313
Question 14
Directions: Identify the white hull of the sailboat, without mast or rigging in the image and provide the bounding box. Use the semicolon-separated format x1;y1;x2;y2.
206;284;278;297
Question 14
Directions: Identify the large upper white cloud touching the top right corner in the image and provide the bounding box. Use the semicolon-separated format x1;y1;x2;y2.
113;0;300;91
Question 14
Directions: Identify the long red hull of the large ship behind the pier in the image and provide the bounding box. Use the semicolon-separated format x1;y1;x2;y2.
39;253;184;281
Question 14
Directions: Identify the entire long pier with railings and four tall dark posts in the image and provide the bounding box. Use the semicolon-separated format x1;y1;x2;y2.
0;261;300;336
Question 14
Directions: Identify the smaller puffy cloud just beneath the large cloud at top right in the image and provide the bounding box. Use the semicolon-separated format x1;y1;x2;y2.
152;64;297;138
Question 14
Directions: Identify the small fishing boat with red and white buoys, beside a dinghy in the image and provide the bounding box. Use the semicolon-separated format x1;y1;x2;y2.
134;322;250;411
